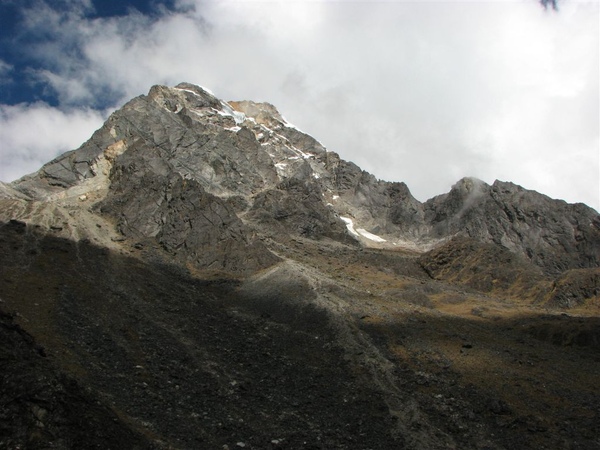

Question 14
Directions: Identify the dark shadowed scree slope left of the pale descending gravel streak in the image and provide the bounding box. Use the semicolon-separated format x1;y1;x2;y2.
0;222;403;449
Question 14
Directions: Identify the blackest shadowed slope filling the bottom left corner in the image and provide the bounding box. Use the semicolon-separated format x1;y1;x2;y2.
0;311;151;449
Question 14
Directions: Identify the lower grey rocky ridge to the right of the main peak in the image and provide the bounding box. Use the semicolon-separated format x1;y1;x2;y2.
425;178;600;274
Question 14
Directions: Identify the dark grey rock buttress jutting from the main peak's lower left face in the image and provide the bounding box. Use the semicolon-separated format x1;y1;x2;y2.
98;140;278;274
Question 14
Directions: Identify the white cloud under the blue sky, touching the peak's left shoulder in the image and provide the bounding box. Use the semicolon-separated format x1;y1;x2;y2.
0;103;106;181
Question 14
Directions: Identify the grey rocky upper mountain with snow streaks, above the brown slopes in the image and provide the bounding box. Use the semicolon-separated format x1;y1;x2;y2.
4;83;600;272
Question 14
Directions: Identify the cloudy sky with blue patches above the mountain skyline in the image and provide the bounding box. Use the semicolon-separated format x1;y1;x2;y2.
0;0;600;209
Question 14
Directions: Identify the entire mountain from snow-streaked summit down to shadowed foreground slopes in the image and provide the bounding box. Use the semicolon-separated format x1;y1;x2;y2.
0;83;600;450
